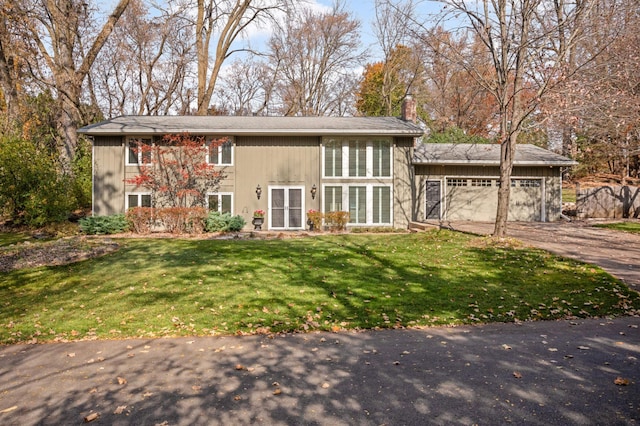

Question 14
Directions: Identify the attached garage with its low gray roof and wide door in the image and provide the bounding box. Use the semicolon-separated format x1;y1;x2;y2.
413;144;575;222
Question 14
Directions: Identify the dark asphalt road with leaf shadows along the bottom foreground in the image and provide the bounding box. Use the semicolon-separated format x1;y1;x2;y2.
0;318;640;425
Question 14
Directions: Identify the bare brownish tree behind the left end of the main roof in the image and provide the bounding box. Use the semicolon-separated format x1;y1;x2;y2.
92;0;195;116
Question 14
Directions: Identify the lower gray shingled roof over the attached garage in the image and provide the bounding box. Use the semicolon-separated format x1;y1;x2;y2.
413;143;578;167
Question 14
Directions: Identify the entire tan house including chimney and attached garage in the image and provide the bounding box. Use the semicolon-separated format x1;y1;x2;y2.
79;99;572;230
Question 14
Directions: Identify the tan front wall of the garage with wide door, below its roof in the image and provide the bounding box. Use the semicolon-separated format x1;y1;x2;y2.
416;165;562;221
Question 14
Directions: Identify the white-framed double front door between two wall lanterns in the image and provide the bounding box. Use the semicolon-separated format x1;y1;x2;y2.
268;186;305;229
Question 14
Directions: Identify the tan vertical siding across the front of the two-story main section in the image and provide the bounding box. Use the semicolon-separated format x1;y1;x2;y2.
93;135;421;229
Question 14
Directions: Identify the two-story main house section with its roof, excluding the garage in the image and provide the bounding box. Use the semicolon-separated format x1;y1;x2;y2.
79;102;423;230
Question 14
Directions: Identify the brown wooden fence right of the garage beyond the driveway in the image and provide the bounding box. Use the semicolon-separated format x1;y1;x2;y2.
576;185;640;219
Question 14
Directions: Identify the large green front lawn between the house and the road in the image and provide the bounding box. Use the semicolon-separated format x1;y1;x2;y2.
0;231;640;343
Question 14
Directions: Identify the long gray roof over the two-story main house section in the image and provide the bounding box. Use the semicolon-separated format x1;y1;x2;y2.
78;115;423;137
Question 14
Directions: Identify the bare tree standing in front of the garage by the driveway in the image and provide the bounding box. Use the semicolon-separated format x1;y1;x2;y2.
404;0;593;237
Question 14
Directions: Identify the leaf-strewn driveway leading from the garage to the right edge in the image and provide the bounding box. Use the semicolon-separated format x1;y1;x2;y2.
444;221;640;291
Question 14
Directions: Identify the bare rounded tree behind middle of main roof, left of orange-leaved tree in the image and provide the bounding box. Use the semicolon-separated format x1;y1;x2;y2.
268;2;362;116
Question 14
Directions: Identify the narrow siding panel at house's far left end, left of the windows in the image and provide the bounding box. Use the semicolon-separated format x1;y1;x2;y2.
93;136;125;216
